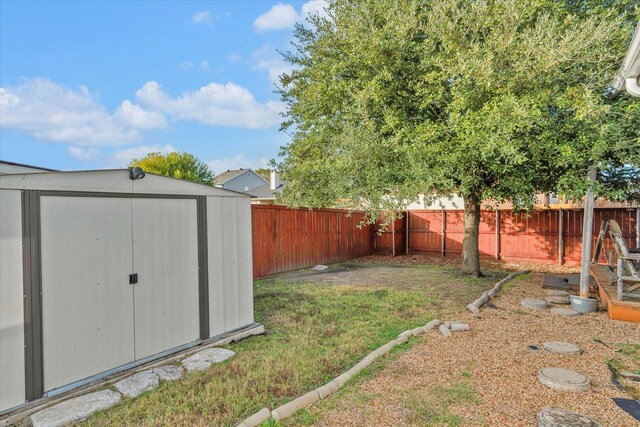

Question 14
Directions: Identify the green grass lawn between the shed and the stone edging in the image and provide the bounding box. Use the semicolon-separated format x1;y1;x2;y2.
86;264;505;426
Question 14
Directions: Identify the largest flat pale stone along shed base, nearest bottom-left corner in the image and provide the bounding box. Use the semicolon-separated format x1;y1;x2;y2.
31;390;121;427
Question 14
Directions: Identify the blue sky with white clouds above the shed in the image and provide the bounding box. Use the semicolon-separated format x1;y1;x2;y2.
0;0;325;173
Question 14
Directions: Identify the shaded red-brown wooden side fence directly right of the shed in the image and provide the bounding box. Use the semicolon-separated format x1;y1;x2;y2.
251;205;374;278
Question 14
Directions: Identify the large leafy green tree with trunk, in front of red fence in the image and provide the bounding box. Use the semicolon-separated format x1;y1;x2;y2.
278;0;639;275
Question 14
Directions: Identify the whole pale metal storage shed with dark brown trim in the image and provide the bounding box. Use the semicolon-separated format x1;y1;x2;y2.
0;170;253;413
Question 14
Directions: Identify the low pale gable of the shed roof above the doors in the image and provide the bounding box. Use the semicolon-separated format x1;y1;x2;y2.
0;169;249;197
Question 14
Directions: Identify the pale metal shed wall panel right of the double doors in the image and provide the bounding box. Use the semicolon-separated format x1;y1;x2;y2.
207;196;253;337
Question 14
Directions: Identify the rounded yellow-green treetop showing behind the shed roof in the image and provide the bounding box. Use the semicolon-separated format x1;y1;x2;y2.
129;152;215;185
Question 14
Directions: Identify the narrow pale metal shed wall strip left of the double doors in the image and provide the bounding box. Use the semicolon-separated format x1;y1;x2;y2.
0;190;25;410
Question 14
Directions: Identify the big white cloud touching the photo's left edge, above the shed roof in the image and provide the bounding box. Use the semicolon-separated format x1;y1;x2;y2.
0;78;139;146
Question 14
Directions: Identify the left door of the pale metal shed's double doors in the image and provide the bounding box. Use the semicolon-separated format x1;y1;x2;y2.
40;196;134;390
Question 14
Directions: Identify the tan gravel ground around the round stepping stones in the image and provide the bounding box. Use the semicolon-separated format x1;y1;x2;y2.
317;274;640;427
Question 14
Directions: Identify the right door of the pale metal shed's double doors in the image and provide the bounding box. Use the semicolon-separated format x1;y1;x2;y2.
133;198;200;359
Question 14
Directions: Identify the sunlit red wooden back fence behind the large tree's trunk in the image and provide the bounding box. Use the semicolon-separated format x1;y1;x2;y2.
374;208;639;265
